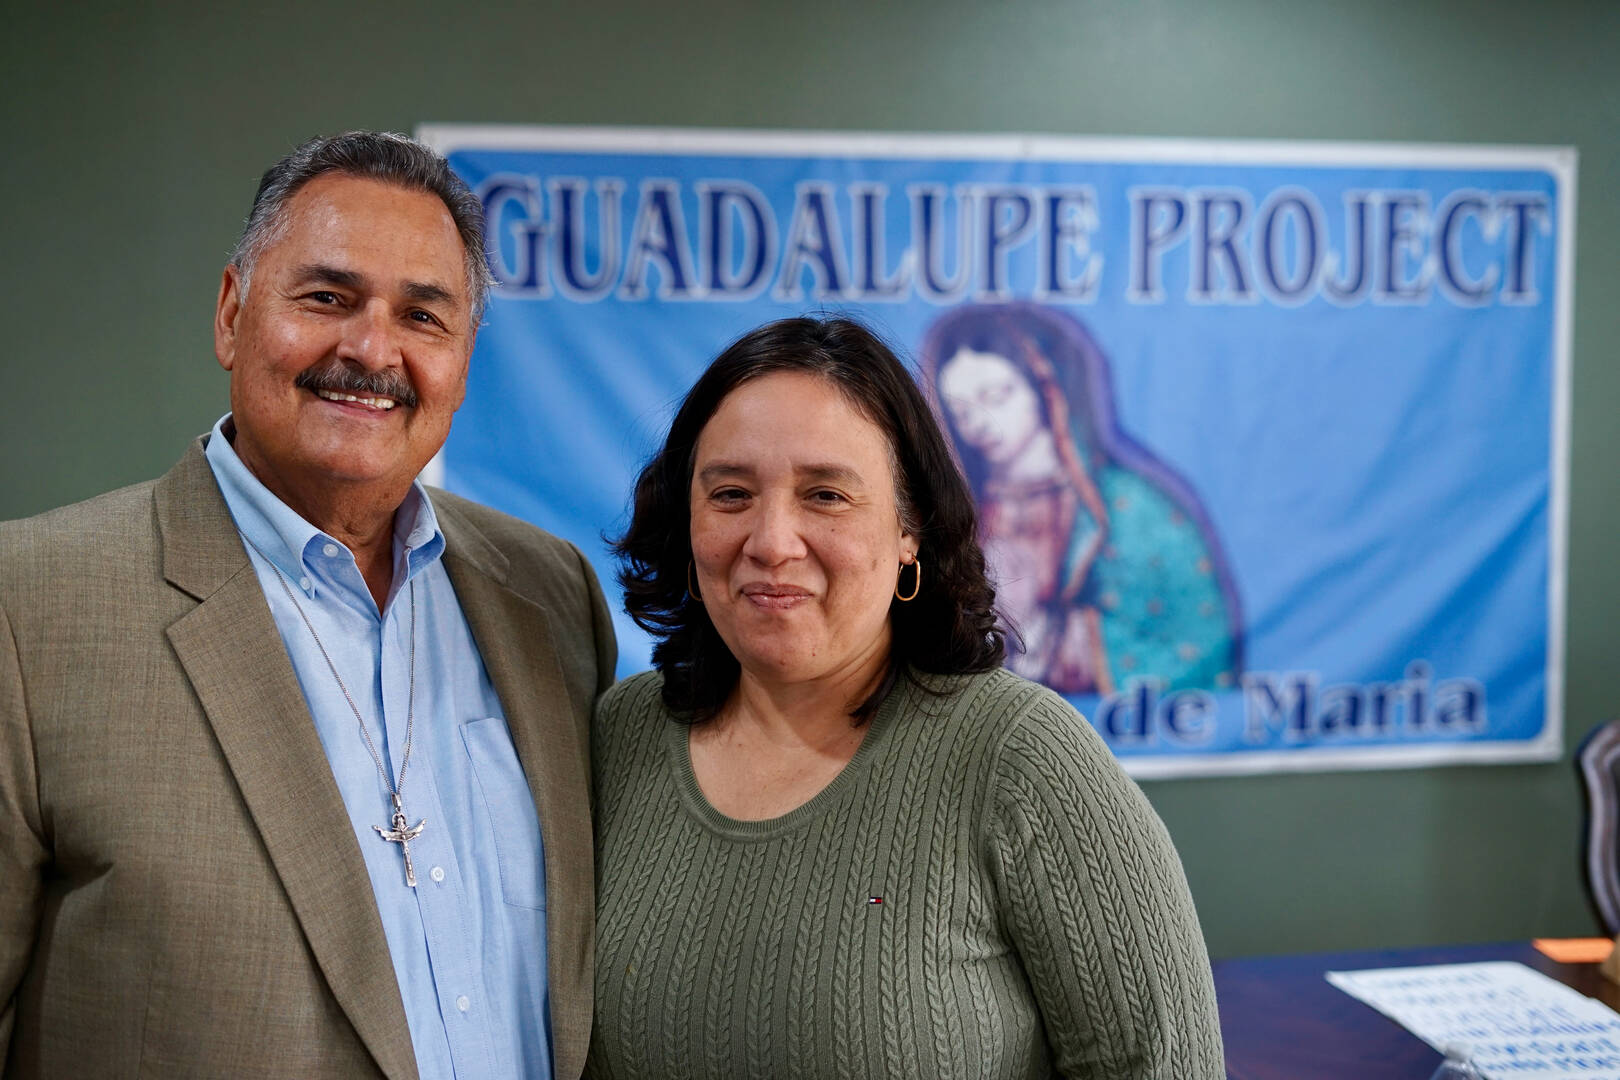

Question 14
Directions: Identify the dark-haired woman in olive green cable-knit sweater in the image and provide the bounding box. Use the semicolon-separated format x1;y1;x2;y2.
590;319;1223;1080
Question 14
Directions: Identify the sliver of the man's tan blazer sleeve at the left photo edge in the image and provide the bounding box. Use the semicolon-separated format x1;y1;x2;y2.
0;595;49;1069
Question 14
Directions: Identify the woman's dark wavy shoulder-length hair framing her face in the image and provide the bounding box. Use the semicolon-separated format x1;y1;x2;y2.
614;317;1006;722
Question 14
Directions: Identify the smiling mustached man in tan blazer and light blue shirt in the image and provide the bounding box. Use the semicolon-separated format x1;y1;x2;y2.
0;133;614;1078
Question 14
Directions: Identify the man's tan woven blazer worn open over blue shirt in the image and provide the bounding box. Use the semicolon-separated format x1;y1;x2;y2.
0;440;614;1080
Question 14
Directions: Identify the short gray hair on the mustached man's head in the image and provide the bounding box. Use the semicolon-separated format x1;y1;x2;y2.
230;131;494;320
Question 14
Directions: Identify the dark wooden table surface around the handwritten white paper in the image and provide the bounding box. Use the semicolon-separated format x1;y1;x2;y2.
1213;942;1620;1080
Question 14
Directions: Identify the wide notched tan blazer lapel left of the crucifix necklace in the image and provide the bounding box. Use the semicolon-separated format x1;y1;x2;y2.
156;440;416;1080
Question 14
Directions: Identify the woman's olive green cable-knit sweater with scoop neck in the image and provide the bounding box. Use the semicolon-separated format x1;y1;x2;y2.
586;670;1225;1080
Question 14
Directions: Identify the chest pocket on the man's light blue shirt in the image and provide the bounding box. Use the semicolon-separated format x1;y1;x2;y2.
462;716;546;912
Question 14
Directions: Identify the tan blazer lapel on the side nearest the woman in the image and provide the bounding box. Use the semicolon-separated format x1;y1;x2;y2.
439;508;596;1077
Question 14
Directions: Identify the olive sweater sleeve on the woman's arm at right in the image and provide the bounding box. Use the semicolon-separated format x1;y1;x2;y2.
985;693;1225;1080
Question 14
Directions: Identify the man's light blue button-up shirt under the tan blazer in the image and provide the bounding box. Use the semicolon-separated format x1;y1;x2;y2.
207;416;551;1080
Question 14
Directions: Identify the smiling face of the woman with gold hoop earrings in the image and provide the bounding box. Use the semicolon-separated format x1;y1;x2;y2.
690;372;927;688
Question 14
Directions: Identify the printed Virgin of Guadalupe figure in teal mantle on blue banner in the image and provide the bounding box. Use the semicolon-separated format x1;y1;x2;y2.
922;304;1243;695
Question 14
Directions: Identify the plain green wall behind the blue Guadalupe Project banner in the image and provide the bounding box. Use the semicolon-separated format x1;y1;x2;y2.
0;0;1620;955
